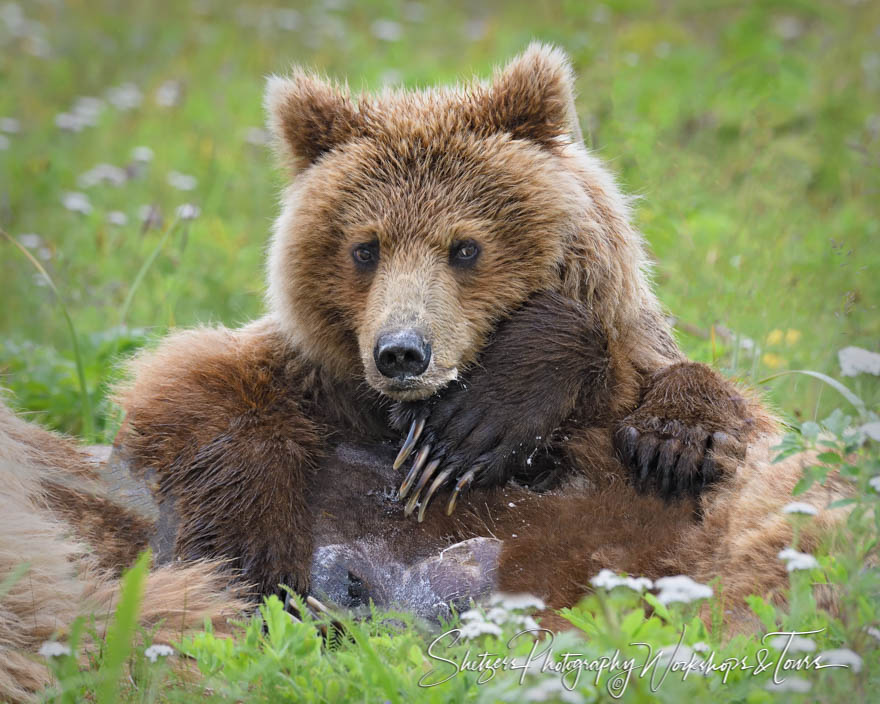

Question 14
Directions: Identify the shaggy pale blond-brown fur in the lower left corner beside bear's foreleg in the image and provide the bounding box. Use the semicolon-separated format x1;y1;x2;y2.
0;403;245;702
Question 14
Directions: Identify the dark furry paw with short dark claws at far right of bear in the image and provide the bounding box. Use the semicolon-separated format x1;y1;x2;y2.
614;416;746;501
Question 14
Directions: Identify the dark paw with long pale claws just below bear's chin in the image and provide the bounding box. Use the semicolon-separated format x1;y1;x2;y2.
394;383;540;523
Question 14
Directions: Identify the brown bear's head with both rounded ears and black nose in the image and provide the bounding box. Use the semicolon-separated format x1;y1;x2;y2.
266;45;586;400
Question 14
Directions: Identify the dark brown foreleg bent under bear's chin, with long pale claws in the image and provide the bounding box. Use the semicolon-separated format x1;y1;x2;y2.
392;292;613;519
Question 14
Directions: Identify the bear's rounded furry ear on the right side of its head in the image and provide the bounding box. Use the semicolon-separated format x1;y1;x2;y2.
483;42;583;147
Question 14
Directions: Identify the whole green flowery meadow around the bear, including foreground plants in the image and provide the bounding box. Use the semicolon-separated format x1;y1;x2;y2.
0;0;880;702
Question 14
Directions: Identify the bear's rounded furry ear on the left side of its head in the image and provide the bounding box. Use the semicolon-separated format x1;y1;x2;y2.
264;68;363;171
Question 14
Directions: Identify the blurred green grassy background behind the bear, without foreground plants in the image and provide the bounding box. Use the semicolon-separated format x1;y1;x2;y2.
0;0;880;439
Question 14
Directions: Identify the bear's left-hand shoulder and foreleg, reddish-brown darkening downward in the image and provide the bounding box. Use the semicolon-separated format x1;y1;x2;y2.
118;325;329;594
